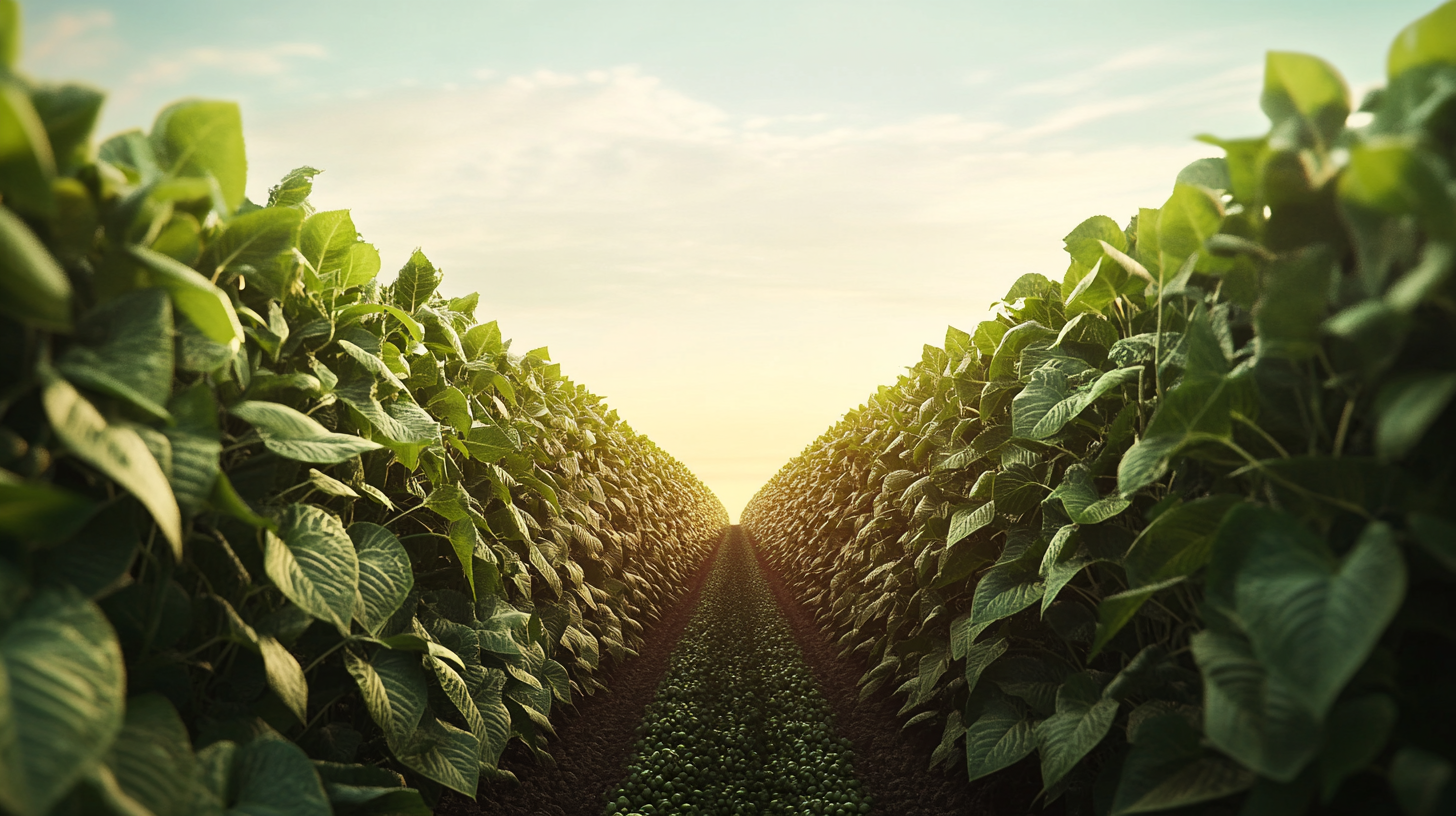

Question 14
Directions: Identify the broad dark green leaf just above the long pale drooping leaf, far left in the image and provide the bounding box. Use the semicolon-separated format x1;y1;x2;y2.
57;289;175;421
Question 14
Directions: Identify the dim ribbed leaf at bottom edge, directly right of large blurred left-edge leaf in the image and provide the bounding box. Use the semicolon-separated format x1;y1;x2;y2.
105;694;202;816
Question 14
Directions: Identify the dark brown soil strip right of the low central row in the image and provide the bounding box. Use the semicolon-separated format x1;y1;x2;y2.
750;538;1041;816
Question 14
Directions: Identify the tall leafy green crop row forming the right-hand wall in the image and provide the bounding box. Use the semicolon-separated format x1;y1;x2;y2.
744;3;1456;816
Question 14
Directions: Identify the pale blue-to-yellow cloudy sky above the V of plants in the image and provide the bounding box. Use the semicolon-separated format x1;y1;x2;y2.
22;0;1436;519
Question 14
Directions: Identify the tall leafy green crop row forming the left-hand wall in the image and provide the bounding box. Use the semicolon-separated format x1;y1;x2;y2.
0;0;727;816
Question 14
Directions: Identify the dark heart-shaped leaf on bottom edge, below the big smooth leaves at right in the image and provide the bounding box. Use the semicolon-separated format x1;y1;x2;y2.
1112;714;1255;816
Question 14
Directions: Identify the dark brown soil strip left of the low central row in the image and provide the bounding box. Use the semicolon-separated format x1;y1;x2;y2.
435;536;718;816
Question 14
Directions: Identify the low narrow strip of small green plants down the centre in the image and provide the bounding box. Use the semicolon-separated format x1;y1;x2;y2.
606;527;869;816
